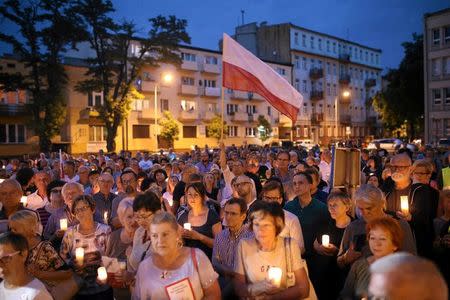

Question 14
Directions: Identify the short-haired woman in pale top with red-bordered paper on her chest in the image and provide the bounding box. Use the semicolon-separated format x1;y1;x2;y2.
133;212;220;300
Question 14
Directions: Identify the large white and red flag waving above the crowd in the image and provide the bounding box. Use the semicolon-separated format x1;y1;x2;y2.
222;33;303;124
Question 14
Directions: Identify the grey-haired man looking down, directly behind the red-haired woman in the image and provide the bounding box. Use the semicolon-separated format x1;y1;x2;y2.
337;184;417;267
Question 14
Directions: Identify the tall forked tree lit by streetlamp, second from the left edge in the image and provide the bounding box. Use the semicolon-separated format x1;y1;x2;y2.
77;0;190;151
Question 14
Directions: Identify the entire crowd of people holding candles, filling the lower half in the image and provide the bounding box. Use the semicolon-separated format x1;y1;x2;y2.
0;143;450;300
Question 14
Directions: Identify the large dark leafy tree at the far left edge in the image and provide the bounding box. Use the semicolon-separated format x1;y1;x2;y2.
0;0;83;152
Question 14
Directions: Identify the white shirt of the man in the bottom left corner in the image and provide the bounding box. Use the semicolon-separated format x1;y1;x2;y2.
0;278;53;300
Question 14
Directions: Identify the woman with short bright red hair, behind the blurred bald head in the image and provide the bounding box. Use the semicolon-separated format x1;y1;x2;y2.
341;217;403;300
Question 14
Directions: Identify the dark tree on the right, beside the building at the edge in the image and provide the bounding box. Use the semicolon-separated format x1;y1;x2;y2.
371;34;424;139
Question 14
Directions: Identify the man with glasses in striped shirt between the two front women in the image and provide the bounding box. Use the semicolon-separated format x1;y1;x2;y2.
212;198;253;299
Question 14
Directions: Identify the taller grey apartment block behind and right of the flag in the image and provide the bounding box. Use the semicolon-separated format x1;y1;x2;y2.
234;22;382;144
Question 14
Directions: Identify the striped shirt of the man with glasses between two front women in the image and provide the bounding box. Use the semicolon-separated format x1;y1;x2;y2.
212;225;254;269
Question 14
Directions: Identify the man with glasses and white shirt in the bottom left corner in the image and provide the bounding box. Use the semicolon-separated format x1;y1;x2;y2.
0;232;53;300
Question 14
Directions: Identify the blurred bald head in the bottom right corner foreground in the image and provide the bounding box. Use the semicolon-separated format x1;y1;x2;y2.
369;252;448;300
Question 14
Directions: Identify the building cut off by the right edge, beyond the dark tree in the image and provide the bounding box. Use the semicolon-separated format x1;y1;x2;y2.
423;9;450;143
